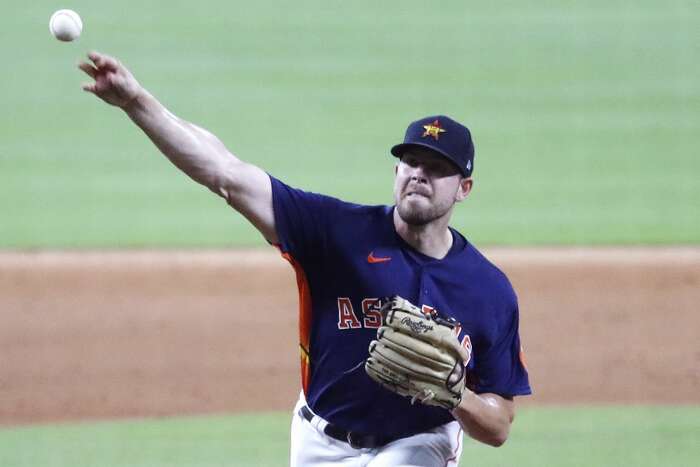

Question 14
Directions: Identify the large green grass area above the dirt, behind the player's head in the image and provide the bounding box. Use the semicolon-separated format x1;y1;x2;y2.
0;0;700;248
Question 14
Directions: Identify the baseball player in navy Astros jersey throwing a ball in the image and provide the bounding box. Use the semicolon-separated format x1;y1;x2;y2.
79;52;530;467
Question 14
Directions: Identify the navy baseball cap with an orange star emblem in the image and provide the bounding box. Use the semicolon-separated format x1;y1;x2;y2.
391;115;474;177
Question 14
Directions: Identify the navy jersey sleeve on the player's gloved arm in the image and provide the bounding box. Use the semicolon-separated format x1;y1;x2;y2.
475;288;532;397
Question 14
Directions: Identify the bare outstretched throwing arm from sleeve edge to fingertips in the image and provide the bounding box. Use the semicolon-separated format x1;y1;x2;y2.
79;52;277;243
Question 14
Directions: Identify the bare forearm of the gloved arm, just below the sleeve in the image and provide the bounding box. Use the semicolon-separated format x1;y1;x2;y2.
452;390;515;447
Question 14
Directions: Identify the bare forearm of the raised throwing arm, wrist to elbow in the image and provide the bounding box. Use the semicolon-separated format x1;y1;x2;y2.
123;90;239;196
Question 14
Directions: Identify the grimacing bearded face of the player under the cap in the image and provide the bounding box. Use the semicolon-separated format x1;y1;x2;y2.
394;148;471;225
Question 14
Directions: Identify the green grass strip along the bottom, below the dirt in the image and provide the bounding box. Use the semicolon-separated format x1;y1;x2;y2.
0;407;700;467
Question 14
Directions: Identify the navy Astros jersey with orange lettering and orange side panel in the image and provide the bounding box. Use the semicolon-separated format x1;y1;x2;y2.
271;177;530;436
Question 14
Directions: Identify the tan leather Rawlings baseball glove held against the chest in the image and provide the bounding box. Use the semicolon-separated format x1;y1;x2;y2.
365;296;469;409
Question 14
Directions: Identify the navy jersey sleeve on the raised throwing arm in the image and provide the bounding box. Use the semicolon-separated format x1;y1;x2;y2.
270;176;335;264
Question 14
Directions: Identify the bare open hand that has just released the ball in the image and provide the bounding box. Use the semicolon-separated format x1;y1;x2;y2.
78;52;142;109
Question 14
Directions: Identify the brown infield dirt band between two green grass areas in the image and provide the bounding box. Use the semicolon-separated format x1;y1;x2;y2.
0;247;700;425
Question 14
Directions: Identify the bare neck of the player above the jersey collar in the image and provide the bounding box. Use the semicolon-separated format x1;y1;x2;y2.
394;208;453;259
